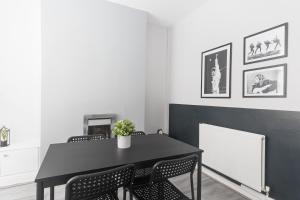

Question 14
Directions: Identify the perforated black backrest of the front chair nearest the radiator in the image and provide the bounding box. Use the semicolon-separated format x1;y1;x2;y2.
150;154;198;183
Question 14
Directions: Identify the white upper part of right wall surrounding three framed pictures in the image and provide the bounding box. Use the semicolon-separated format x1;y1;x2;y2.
169;0;300;111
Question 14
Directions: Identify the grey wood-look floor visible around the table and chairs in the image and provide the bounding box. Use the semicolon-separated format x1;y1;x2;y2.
0;175;247;200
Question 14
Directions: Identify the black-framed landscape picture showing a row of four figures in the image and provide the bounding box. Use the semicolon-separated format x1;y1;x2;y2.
244;23;288;65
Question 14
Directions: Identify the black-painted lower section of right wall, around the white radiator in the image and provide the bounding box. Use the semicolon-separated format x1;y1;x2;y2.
169;104;300;200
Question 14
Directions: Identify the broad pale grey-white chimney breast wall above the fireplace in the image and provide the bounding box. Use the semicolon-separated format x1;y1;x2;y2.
42;0;147;157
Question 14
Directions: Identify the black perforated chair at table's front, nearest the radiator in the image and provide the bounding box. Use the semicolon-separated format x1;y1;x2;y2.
132;155;198;200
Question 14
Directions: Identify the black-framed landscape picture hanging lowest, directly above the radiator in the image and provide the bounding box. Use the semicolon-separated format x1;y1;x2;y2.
243;64;287;97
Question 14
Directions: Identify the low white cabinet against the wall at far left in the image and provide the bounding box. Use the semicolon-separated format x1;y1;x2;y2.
0;145;39;187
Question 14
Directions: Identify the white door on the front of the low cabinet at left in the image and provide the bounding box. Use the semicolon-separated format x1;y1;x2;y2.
0;148;38;176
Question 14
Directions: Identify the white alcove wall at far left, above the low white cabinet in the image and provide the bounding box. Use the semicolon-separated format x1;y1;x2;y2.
0;0;41;144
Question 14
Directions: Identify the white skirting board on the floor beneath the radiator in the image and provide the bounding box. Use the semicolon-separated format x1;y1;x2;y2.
202;166;274;200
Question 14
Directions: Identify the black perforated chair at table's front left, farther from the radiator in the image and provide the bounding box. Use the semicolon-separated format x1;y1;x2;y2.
65;165;135;200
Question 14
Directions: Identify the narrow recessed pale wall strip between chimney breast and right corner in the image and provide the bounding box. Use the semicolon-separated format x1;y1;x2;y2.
145;23;168;133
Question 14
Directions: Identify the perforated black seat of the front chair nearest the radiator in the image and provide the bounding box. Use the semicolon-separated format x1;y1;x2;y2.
133;180;190;200
